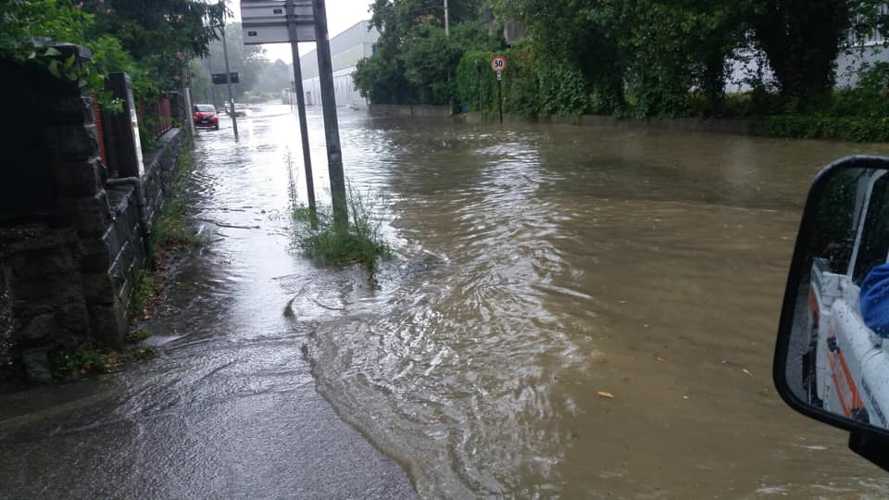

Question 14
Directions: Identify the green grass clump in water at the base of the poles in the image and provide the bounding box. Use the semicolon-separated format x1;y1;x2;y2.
293;184;392;271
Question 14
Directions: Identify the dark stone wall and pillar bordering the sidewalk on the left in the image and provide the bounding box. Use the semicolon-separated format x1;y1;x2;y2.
0;46;191;380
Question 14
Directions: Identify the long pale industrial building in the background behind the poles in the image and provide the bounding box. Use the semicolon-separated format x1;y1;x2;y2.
299;21;380;108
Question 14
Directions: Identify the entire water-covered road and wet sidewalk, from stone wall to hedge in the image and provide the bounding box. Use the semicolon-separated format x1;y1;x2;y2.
0;106;889;498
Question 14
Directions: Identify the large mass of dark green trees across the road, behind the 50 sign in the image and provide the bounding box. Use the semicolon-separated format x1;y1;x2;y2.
356;0;889;125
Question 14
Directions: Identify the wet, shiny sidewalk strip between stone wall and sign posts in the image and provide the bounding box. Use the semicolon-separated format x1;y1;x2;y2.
0;107;416;499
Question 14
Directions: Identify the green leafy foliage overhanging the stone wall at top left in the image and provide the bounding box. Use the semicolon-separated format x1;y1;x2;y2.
0;0;224;107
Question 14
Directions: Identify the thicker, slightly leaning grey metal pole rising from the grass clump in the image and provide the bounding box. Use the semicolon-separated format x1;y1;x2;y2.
312;0;349;229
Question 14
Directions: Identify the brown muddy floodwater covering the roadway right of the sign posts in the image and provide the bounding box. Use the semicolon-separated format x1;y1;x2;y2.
311;107;889;498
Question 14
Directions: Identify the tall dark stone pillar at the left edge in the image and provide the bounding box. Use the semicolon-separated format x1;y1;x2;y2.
0;45;127;380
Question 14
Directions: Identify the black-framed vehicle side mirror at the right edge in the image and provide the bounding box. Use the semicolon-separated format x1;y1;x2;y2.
773;157;889;471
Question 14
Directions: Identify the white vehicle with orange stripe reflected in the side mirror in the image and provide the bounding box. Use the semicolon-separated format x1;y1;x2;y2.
802;171;889;429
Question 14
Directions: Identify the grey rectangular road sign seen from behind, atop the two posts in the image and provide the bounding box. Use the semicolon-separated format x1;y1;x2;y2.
241;0;315;45
